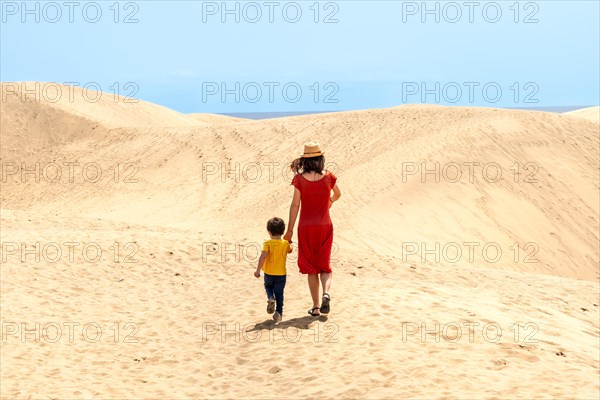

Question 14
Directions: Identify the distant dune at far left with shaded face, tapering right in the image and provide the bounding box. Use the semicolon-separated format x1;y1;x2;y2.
0;82;207;150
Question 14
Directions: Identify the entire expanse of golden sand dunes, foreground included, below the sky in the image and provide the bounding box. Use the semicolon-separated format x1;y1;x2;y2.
0;83;600;398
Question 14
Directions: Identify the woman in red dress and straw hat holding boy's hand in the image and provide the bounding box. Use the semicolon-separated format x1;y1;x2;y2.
283;142;341;316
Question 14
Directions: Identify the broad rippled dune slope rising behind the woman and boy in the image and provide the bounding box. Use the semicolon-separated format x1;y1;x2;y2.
2;99;599;279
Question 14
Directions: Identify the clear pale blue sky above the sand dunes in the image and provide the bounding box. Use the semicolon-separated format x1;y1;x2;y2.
0;0;600;113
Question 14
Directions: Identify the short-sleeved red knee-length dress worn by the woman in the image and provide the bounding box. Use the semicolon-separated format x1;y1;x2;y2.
292;172;337;274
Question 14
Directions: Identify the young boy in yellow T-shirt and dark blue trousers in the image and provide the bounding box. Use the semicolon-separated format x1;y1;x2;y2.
254;218;292;322
